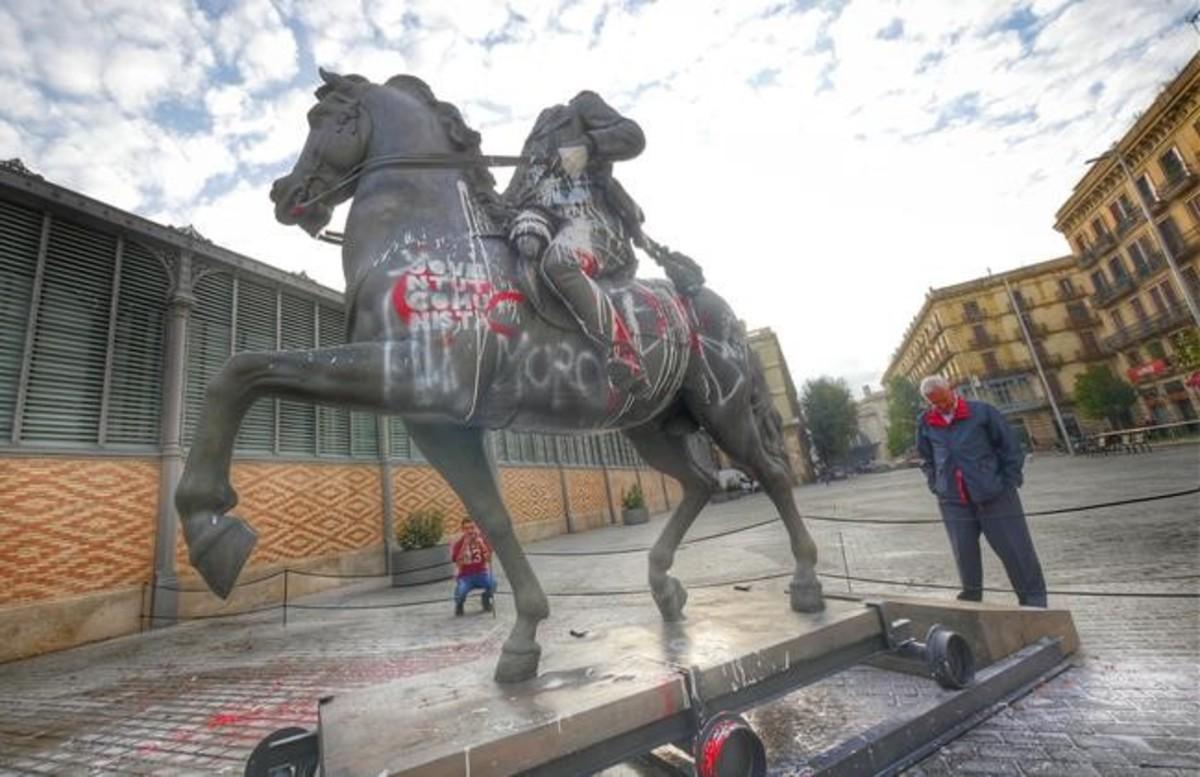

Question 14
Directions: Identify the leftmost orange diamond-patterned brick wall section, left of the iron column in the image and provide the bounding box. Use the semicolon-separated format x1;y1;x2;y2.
0;458;158;604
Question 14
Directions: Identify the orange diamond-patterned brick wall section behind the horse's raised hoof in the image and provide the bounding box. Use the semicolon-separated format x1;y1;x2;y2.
176;462;383;574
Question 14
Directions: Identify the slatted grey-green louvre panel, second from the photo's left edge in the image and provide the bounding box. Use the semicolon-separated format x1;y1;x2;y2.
20;219;116;445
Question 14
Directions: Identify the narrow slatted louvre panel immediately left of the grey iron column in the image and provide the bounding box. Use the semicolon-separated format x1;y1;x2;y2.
104;240;170;446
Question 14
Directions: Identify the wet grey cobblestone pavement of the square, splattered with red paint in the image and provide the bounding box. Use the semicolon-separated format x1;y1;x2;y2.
0;447;1200;775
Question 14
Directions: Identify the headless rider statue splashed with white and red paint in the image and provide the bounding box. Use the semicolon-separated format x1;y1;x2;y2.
504;91;650;396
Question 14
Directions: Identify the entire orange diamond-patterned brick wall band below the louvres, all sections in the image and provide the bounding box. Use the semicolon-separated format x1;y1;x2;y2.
0;457;682;606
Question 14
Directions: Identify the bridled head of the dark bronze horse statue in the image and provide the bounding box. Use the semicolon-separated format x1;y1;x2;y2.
271;70;371;235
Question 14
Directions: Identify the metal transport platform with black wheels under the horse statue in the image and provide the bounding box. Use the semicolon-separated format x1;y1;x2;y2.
246;590;1078;777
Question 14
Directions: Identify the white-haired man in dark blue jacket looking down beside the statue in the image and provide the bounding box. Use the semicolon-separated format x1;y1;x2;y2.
917;375;1046;607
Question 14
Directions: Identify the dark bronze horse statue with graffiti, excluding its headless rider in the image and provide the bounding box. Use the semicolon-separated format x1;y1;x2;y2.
175;71;824;682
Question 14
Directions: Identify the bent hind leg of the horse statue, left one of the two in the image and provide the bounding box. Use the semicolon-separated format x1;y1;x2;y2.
625;424;716;621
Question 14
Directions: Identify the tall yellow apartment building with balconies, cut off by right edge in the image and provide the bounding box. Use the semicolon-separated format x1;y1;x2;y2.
1055;55;1200;423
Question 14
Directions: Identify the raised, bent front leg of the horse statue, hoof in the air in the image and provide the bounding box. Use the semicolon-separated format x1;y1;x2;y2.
175;343;457;597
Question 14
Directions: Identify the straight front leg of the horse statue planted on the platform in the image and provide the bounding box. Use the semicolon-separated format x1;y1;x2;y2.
406;422;550;682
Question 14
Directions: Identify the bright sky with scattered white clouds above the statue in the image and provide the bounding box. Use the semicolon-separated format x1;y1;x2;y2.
0;0;1200;389
